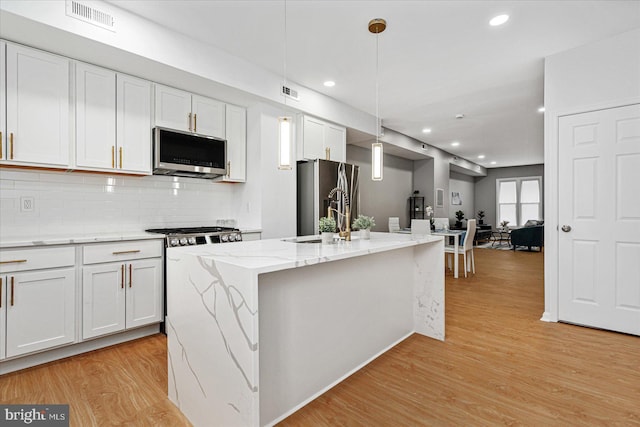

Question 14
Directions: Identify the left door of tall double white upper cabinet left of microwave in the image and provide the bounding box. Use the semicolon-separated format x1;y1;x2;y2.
76;63;116;169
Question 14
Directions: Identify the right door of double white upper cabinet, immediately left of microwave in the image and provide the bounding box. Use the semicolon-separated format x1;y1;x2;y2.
116;74;152;174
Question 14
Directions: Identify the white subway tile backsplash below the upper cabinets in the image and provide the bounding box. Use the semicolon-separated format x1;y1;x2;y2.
0;169;238;240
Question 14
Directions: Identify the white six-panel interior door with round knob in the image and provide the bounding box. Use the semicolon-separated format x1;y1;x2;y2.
558;104;640;335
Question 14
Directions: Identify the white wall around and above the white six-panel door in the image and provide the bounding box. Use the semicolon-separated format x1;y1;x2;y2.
542;29;640;321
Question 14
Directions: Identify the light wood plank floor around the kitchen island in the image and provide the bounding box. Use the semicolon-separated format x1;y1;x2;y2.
0;249;640;427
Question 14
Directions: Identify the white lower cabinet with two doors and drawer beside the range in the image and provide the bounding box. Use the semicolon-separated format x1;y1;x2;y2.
82;241;163;339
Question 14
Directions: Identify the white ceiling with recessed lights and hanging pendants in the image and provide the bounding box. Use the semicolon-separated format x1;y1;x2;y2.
109;0;640;168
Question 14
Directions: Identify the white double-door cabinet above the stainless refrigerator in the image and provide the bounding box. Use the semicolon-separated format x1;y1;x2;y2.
297;115;347;162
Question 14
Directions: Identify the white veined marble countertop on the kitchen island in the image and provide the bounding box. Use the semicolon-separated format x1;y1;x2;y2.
167;233;443;274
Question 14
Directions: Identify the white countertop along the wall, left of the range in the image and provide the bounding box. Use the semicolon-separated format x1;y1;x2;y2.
0;231;164;249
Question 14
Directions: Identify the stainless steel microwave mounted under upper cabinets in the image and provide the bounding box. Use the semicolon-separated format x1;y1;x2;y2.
153;127;227;179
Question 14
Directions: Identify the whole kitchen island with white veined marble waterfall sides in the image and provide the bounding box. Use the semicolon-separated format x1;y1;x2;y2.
166;233;444;426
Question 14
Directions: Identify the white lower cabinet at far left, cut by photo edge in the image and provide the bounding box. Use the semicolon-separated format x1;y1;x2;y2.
0;247;76;359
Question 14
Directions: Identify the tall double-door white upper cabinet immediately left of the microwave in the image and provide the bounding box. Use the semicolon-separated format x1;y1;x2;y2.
76;63;151;175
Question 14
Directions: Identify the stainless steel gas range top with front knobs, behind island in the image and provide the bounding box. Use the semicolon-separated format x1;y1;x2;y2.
145;227;242;248
